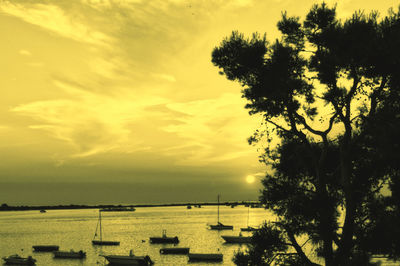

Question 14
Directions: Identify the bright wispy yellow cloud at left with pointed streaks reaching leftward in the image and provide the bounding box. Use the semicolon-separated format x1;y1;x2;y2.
11;81;156;157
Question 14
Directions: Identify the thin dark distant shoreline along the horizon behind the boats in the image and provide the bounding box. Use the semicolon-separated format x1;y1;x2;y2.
0;201;261;211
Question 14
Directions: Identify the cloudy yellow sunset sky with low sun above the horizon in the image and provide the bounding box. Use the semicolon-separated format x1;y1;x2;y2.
0;0;399;205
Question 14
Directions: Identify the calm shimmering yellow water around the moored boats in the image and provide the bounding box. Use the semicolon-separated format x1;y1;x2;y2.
0;206;269;266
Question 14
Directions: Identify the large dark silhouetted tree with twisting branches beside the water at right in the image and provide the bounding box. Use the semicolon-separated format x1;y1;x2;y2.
212;3;400;266
